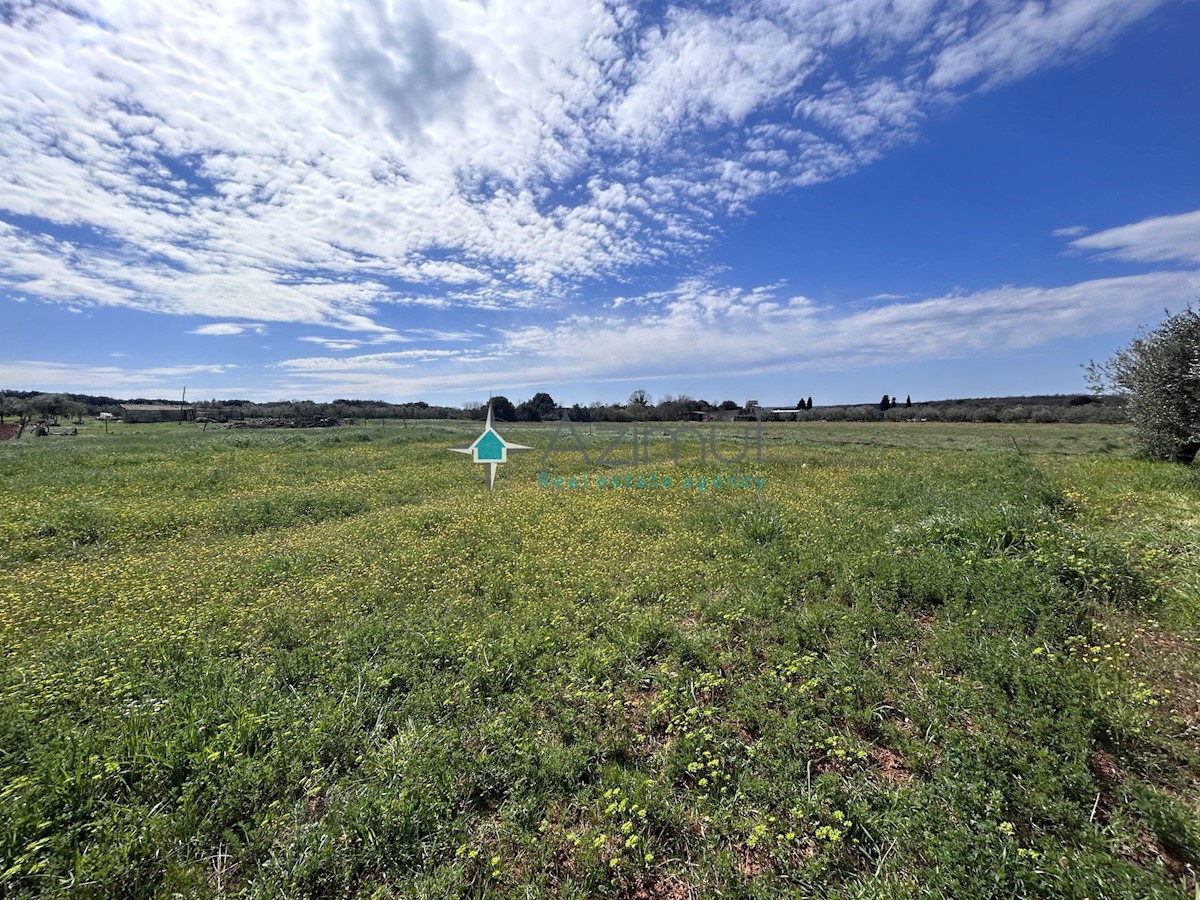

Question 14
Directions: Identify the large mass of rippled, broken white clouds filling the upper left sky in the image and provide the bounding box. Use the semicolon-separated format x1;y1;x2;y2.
0;0;1159;331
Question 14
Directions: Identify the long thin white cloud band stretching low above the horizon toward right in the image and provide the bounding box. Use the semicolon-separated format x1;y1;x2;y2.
267;264;1200;396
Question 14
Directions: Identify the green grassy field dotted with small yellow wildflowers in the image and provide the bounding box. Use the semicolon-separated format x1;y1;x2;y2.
0;422;1200;900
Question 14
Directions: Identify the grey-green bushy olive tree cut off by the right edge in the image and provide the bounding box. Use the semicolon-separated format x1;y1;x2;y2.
1087;306;1200;463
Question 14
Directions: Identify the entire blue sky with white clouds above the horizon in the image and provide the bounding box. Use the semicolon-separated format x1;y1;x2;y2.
0;0;1200;406
